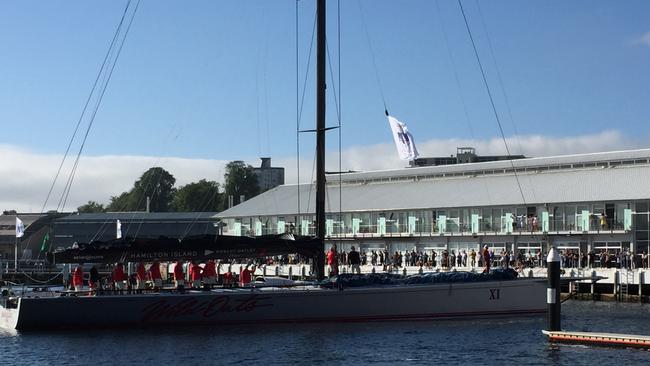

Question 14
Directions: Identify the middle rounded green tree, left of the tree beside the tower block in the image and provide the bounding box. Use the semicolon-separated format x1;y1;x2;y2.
171;179;221;212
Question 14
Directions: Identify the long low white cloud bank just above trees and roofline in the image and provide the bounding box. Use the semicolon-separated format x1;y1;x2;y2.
0;131;640;212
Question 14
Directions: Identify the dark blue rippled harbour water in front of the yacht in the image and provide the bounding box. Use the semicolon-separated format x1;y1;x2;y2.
0;301;650;365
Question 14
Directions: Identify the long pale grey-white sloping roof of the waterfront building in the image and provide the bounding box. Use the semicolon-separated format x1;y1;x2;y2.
217;149;650;218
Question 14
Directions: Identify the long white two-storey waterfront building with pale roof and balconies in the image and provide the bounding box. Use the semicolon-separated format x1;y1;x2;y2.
216;149;650;266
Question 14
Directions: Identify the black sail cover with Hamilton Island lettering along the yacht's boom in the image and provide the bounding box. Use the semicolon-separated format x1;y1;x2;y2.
47;234;322;263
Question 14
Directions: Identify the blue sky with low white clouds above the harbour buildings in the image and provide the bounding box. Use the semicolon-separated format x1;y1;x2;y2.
0;0;650;212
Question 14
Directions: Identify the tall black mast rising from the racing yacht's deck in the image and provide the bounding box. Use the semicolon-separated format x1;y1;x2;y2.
314;0;327;281
